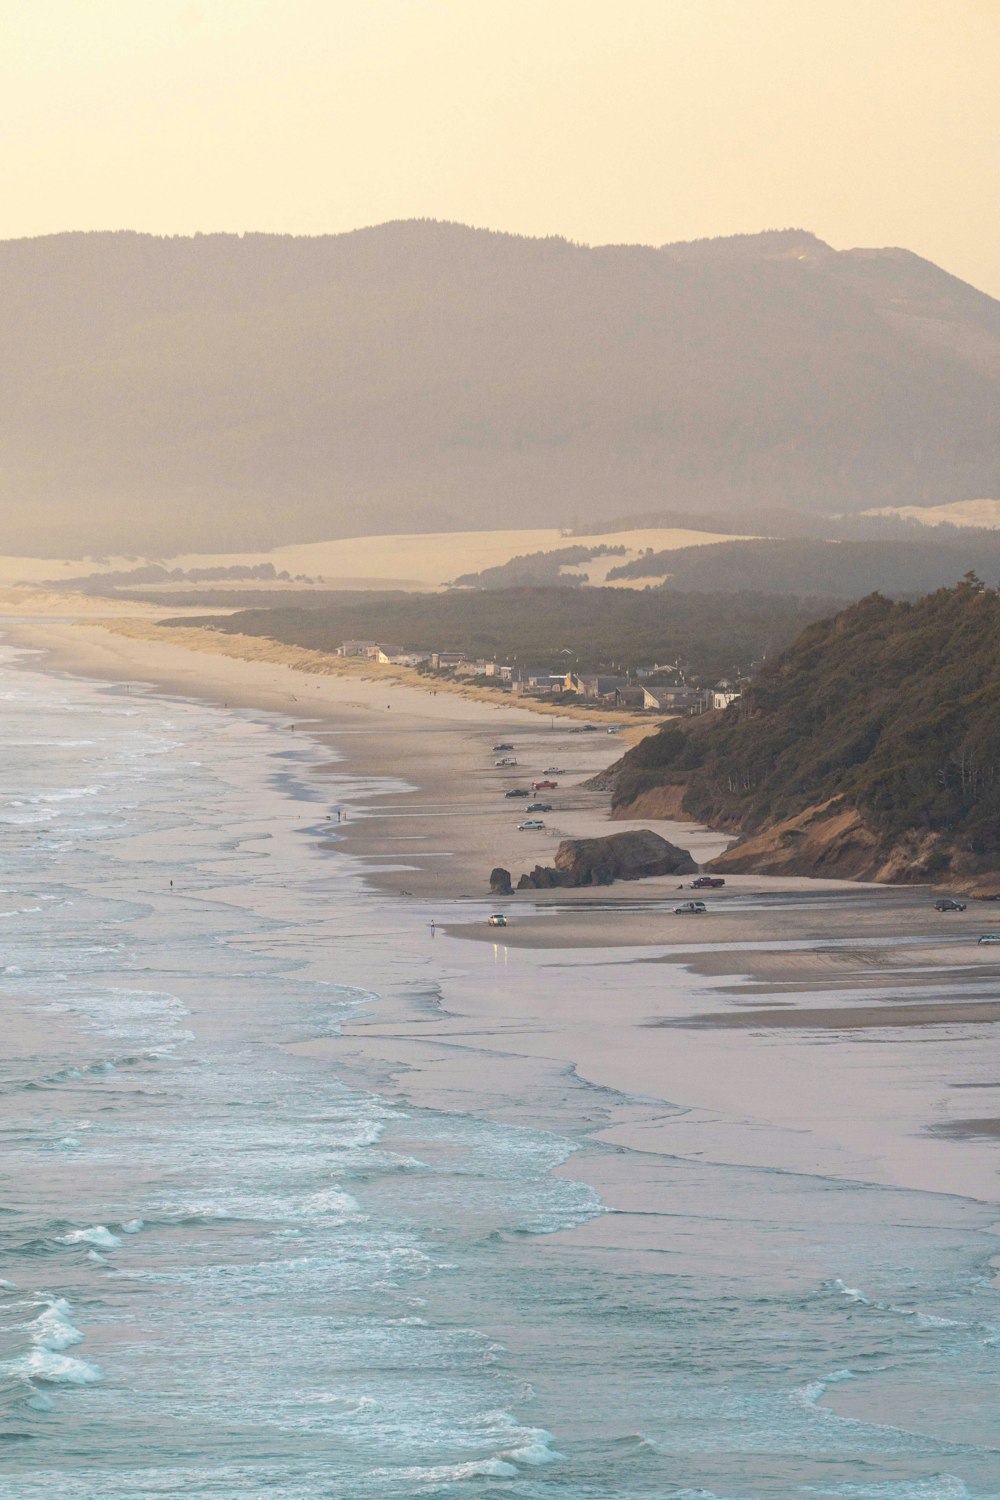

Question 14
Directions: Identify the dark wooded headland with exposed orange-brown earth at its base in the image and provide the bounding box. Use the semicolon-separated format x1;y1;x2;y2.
615;578;1000;879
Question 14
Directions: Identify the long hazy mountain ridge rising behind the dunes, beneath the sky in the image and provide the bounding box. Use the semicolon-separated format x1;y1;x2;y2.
0;221;1000;555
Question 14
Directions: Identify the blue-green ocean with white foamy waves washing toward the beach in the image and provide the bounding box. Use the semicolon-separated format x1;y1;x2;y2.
0;647;1000;1500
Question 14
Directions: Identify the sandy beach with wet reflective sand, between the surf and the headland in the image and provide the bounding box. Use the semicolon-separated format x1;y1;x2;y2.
10;609;1000;1206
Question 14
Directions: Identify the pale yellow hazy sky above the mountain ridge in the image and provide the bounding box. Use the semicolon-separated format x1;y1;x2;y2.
7;0;1000;296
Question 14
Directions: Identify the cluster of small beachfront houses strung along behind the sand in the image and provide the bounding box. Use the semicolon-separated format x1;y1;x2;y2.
337;641;739;714
